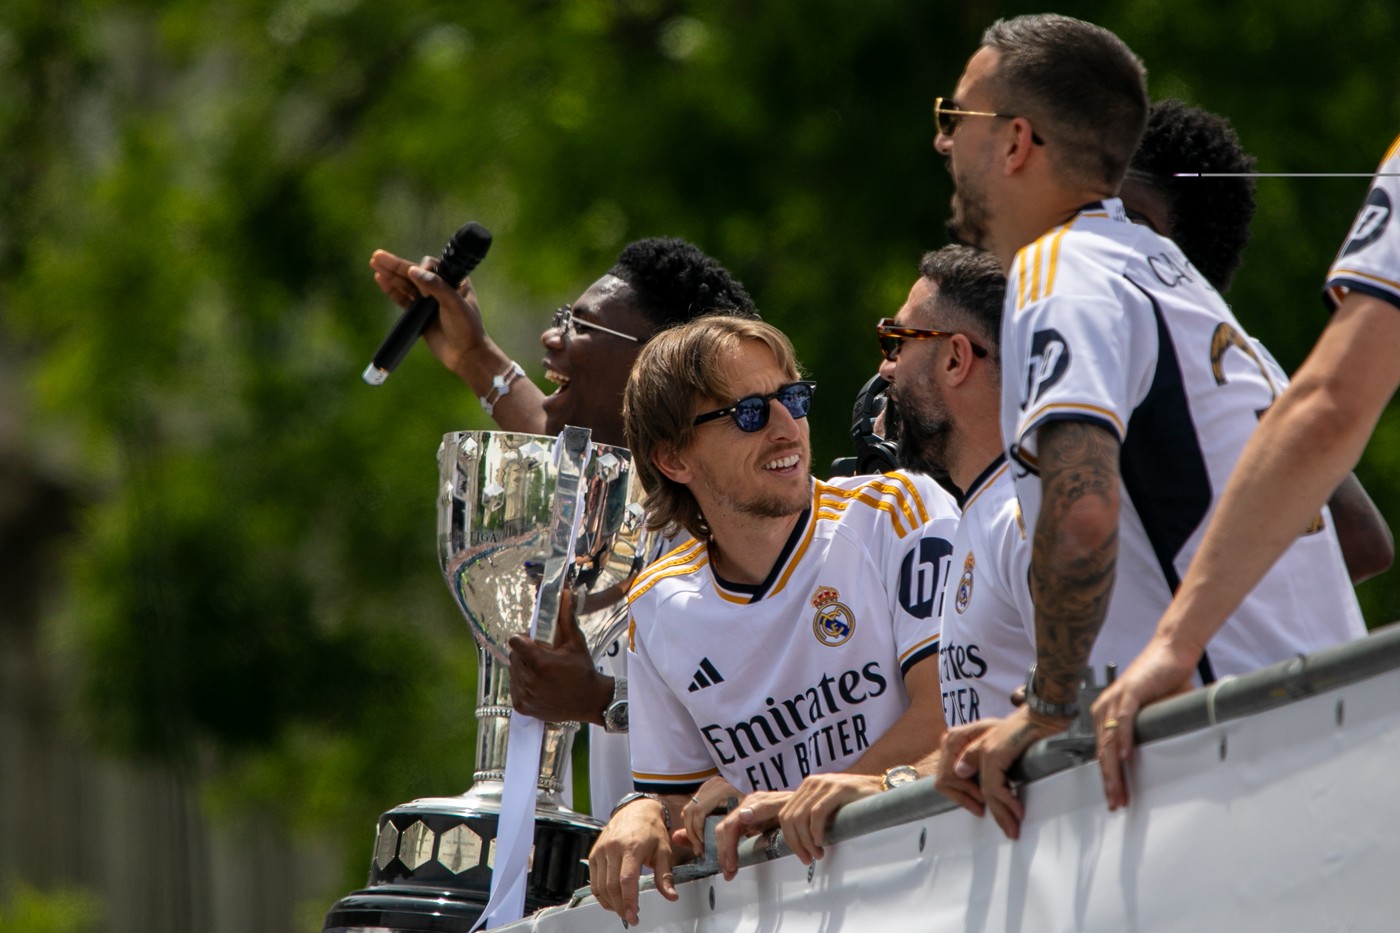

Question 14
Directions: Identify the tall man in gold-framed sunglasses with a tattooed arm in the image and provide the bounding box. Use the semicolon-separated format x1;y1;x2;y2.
937;14;1364;838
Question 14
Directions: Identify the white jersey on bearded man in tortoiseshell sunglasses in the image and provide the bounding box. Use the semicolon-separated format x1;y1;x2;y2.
938;457;1036;727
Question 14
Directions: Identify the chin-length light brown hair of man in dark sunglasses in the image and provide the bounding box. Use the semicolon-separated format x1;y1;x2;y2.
622;314;801;539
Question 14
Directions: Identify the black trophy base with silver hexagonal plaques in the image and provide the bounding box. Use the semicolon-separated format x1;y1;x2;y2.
322;789;602;933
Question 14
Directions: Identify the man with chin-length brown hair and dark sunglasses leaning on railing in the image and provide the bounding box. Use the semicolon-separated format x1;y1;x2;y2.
589;317;958;923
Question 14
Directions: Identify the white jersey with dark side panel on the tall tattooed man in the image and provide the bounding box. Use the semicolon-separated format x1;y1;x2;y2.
1001;199;1365;682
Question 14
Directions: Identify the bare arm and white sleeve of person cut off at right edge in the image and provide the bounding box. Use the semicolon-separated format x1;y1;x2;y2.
1093;130;1400;807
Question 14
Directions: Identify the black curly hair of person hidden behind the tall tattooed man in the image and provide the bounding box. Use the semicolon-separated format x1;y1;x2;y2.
1128;99;1254;294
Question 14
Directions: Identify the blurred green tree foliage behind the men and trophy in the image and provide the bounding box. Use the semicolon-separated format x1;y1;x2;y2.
0;0;1400;907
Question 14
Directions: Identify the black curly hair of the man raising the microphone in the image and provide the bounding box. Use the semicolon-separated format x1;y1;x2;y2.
608;237;759;331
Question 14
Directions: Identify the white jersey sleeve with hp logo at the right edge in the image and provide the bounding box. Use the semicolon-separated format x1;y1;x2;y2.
1323;136;1400;310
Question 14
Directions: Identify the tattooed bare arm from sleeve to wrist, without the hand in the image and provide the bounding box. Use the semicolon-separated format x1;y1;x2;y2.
1030;422;1119;699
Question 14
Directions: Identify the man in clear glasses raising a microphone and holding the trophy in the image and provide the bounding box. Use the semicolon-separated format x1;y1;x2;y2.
370;237;757;817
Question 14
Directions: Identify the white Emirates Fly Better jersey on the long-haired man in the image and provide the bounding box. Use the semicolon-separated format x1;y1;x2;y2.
627;472;958;793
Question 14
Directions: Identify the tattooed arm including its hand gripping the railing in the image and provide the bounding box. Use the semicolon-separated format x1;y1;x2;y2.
945;422;1119;839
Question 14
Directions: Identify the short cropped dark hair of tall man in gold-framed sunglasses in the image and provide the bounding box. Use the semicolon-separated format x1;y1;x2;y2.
981;13;1147;191
